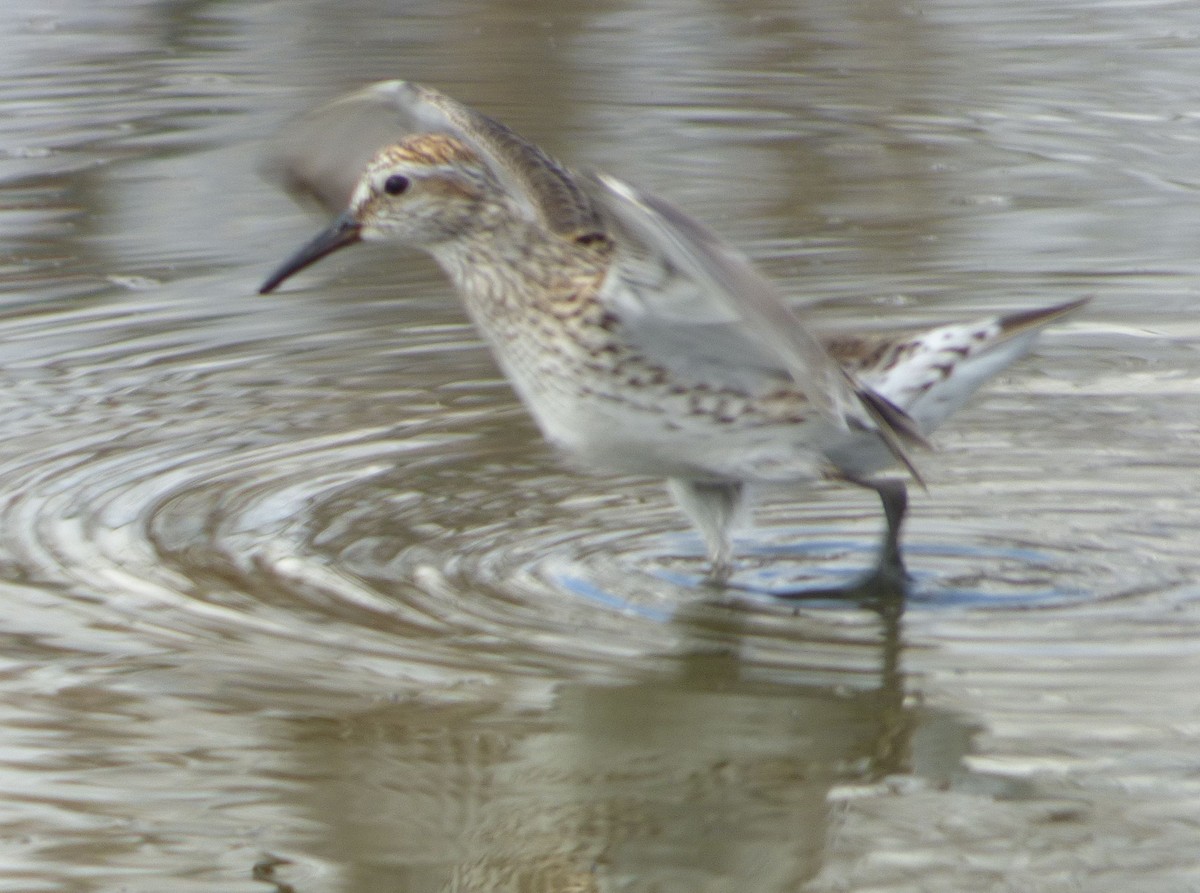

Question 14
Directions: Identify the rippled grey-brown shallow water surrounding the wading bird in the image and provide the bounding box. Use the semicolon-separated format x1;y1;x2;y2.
0;0;1200;893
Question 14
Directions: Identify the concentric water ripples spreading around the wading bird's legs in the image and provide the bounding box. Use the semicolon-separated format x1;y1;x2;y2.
0;292;1192;696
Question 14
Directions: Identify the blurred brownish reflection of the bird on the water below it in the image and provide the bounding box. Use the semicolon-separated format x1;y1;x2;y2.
278;592;926;893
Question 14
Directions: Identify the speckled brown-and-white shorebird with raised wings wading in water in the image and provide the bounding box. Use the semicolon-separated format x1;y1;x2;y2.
259;80;1086;583
